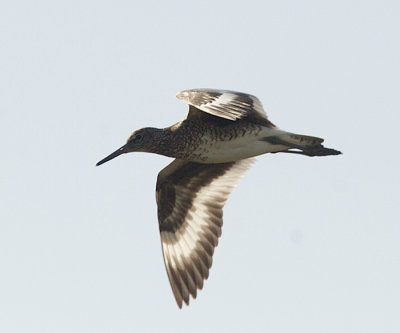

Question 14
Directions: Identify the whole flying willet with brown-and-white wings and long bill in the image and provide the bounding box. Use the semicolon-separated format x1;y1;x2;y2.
96;89;341;308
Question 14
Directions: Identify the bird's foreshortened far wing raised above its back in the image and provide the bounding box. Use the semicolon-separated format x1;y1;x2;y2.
176;89;267;120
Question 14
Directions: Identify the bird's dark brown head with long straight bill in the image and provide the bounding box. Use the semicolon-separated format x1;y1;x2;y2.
96;127;159;166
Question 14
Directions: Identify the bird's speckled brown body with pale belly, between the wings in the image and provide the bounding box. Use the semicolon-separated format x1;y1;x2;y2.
147;115;282;164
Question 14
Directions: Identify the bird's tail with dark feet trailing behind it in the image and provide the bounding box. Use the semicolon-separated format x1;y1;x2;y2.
264;132;341;156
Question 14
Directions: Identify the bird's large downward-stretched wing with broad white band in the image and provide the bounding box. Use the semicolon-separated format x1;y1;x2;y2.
156;158;254;308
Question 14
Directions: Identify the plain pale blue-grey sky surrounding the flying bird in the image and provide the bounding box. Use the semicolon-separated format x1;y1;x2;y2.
0;0;400;333
